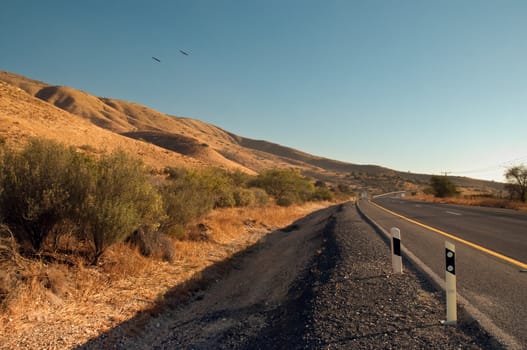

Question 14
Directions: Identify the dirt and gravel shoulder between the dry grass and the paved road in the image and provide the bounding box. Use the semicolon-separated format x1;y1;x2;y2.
78;203;501;349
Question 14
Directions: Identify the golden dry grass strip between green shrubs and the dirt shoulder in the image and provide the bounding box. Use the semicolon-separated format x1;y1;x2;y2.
0;203;329;349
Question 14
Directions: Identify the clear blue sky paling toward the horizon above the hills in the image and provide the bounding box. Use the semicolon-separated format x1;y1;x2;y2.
0;0;527;181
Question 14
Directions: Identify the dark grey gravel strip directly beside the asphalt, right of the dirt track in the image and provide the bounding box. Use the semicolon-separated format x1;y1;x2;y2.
304;205;501;349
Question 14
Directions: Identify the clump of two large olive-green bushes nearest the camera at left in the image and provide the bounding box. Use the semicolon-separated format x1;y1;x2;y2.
0;139;162;261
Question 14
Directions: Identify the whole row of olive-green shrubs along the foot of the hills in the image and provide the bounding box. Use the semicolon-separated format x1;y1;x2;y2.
0;139;335;263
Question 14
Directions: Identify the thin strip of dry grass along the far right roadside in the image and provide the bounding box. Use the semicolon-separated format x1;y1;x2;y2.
406;193;527;212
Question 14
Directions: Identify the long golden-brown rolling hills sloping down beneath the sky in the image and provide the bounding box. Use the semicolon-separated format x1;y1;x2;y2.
0;71;502;191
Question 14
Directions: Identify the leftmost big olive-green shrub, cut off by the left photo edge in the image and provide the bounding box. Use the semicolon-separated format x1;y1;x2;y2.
0;139;92;251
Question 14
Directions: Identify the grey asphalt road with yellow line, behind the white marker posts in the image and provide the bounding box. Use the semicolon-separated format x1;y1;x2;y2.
360;198;527;349
